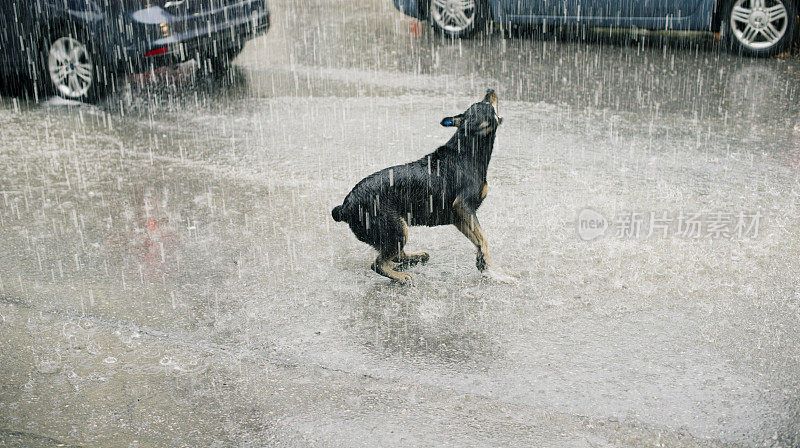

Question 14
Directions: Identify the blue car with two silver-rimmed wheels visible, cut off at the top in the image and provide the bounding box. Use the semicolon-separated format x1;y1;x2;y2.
394;0;800;56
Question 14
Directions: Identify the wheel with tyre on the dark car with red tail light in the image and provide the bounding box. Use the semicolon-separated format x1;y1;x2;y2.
43;33;103;102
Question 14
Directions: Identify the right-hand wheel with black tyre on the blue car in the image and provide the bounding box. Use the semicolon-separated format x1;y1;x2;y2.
723;0;797;56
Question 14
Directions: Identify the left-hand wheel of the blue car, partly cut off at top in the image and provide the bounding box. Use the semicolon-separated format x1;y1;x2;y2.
428;0;487;39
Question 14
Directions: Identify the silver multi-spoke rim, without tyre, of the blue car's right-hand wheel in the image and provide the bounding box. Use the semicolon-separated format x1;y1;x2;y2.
730;0;789;50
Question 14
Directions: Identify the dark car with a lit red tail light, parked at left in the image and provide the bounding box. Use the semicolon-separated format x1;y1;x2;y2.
0;0;270;101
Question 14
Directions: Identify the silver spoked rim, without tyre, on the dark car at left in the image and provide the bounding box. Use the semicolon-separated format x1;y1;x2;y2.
47;37;94;98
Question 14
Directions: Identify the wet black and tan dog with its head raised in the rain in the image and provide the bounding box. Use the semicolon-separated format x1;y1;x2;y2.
331;89;503;283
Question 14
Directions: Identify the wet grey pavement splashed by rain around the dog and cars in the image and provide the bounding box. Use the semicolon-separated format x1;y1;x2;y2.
0;1;800;447
